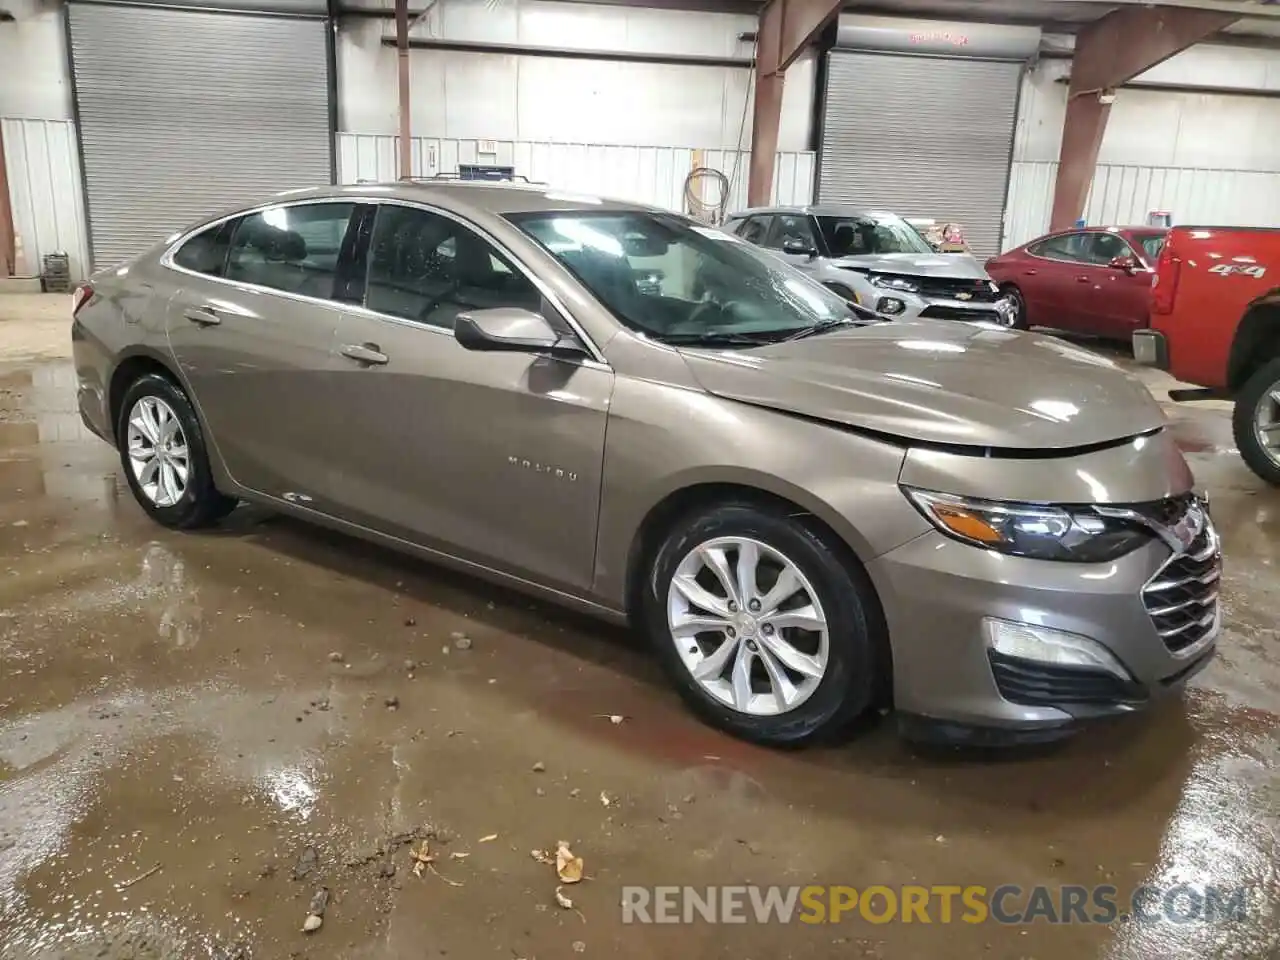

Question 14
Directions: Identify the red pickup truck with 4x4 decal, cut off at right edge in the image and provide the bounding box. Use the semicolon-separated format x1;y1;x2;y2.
1133;227;1280;485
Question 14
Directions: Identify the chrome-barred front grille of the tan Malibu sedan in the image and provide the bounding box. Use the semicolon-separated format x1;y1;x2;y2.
1142;525;1222;654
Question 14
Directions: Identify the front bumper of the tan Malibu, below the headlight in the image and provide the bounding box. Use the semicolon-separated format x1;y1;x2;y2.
868;522;1221;741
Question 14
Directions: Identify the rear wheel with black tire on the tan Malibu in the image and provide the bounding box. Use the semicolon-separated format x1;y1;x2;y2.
115;374;237;530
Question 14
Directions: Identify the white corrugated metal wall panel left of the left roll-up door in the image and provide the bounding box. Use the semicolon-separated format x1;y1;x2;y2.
0;119;88;280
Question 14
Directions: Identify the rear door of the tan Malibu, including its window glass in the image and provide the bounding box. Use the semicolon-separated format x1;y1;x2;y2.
168;202;357;506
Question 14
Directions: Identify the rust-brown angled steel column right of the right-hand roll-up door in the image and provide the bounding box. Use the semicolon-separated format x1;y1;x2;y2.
1050;6;1239;230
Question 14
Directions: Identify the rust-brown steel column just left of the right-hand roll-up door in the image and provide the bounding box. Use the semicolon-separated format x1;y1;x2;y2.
746;0;841;206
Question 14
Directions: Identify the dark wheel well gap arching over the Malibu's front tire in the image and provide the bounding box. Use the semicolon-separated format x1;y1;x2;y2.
626;483;893;703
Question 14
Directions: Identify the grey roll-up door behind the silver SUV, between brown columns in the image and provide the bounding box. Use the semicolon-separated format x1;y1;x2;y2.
818;50;1021;256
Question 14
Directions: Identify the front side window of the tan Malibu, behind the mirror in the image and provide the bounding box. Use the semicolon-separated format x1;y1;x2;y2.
365;204;543;330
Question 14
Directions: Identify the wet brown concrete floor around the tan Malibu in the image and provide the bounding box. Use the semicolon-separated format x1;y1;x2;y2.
0;296;1280;960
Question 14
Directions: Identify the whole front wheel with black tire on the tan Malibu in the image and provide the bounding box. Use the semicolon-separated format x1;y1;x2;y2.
643;502;887;746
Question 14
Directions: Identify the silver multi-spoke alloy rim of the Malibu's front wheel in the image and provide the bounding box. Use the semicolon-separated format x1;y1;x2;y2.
667;536;829;717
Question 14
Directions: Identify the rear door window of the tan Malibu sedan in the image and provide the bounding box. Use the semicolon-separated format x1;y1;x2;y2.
227;204;356;300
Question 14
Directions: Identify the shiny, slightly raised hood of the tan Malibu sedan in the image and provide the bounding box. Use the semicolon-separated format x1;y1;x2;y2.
684;320;1165;449
